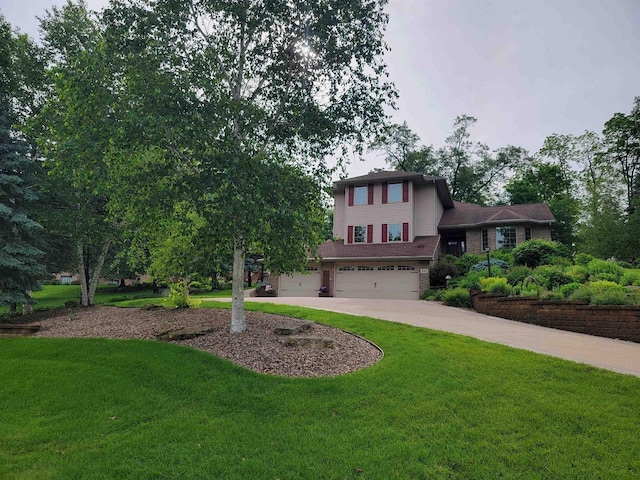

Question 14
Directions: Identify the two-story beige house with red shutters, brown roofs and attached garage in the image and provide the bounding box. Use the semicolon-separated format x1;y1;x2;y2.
273;172;554;299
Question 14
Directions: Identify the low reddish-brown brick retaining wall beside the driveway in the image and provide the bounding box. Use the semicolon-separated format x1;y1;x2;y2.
472;293;640;342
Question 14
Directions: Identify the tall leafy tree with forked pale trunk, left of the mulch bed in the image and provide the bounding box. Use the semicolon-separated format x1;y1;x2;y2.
32;1;117;306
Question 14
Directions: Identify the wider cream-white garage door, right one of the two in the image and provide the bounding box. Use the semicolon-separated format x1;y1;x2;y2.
336;264;418;300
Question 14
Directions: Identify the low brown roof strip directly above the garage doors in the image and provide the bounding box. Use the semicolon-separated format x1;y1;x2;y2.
316;235;440;260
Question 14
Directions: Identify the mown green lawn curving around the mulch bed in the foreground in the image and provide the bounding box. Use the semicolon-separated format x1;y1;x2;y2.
0;292;640;479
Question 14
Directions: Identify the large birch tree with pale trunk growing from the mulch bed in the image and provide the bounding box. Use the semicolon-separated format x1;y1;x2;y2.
104;0;394;332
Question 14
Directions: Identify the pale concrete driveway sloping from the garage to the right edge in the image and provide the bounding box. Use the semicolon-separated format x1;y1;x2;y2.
235;296;640;377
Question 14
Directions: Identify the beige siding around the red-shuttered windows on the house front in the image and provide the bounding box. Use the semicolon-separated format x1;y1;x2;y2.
344;182;415;243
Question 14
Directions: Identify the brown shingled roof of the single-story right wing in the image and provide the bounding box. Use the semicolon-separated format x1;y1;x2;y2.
438;202;555;228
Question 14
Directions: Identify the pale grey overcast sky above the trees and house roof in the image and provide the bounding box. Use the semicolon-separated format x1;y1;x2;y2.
0;0;640;176
